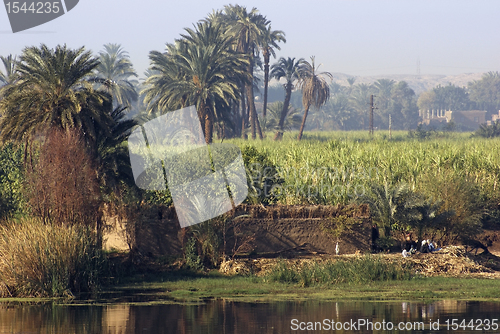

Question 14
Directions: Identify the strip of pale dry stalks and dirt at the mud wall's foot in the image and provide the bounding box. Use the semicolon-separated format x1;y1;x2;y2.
219;246;500;278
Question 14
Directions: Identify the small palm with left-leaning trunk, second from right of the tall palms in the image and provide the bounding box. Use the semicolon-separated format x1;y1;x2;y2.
271;57;304;140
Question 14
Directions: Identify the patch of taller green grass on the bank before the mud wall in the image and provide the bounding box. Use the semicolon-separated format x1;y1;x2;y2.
267;255;413;287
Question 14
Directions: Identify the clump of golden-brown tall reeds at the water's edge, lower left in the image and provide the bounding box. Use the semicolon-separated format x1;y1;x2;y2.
0;220;104;297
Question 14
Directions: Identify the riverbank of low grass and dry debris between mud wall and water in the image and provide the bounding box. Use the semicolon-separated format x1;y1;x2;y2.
98;247;500;303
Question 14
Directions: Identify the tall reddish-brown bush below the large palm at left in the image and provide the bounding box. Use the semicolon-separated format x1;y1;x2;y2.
27;130;101;226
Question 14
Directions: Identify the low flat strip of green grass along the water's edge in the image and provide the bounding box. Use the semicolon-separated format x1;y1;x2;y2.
97;274;500;304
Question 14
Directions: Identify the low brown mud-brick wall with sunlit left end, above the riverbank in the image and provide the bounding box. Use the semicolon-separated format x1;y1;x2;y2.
105;205;371;257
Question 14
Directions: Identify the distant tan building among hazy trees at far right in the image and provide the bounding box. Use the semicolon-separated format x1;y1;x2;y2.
419;110;486;130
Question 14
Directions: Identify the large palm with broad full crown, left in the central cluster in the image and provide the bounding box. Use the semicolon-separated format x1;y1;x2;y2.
143;21;249;143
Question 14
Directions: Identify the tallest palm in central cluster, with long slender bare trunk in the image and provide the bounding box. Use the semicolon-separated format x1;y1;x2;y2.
220;5;269;139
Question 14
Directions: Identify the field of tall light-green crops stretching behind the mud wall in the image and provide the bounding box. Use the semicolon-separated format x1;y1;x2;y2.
232;131;500;204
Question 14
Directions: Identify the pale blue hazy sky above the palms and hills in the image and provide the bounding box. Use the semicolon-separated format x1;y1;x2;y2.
0;0;500;76
